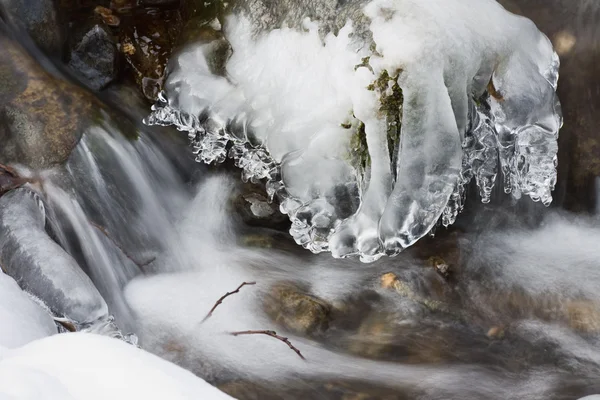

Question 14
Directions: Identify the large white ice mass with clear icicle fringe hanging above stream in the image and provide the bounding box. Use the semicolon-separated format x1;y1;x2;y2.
146;0;562;261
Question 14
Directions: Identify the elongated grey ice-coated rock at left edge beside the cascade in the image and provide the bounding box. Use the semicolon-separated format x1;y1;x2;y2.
0;188;108;324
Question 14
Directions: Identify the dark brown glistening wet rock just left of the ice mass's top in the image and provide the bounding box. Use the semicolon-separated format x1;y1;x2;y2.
119;9;181;101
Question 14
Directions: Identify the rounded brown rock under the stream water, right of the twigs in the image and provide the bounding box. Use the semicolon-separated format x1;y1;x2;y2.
263;283;331;335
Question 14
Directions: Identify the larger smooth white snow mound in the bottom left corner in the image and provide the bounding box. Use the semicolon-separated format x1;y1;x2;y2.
0;333;231;400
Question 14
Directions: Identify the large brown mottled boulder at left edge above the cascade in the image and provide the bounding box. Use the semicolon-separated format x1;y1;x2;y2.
0;37;98;169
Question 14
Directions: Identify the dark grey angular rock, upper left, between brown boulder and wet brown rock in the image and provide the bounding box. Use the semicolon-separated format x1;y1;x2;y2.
68;19;119;90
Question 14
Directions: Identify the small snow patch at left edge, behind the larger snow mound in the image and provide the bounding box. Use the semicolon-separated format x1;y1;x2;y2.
0;273;57;348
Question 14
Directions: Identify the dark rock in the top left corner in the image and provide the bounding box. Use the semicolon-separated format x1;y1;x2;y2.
0;0;64;55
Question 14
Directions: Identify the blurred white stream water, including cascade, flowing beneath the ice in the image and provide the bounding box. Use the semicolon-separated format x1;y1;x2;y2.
3;0;600;400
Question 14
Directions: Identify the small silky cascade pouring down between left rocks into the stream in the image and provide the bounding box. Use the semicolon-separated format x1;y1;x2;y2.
42;120;190;332
